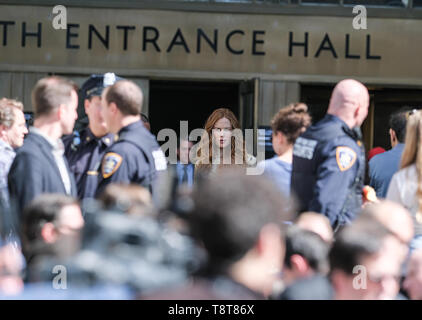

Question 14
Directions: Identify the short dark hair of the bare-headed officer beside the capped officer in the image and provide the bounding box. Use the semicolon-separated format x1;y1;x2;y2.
105;80;143;116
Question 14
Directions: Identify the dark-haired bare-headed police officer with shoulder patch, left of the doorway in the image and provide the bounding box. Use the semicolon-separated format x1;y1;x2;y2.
96;80;167;198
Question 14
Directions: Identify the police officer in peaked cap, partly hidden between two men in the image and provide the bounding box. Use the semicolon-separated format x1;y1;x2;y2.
63;73;122;199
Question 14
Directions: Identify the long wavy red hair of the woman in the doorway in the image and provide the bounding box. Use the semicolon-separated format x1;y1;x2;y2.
196;108;246;168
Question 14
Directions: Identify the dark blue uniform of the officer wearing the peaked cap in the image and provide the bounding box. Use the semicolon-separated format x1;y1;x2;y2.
63;128;115;199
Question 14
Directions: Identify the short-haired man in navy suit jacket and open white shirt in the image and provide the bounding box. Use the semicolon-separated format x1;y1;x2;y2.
8;77;78;215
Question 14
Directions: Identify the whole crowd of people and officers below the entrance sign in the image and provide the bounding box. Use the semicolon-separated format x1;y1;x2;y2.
0;73;422;300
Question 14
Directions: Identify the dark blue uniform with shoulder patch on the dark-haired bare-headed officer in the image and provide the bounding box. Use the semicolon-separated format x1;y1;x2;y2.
96;121;167;196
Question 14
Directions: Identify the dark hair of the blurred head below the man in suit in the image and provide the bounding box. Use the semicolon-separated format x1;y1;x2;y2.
21;193;78;242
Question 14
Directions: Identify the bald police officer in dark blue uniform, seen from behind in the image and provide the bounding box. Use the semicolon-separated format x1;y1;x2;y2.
291;79;369;230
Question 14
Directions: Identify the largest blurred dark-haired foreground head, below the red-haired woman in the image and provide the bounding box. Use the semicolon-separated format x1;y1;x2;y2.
191;169;290;295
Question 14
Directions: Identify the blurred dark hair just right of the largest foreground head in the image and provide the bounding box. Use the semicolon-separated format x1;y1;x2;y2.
284;226;330;274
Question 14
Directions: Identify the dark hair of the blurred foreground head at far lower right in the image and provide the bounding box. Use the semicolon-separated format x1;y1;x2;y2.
329;216;392;274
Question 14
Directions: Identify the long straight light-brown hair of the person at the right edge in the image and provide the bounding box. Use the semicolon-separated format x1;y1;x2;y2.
400;111;422;223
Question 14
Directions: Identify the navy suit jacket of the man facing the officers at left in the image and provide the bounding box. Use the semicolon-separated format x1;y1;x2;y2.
8;133;77;215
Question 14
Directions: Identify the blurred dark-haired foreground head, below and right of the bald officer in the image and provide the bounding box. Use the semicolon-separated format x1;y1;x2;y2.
329;216;403;300
